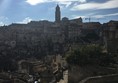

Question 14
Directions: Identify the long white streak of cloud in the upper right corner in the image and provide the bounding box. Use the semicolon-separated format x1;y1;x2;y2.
71;0;118;10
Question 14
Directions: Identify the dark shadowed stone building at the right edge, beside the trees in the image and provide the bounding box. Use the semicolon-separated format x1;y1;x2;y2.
102;21;118;53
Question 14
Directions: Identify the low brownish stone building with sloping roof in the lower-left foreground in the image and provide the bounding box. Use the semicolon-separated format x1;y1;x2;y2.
18;59;47;74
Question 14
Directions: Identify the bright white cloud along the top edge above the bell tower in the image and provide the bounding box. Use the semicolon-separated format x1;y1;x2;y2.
26;0;86;6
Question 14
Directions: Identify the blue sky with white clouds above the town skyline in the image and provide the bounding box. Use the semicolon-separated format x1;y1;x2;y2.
0;0;118;26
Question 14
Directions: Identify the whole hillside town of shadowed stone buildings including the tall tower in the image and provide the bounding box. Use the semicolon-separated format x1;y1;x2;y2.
0;5;118;83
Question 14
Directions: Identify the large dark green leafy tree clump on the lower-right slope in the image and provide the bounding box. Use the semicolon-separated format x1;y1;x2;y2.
66;45;114;65
